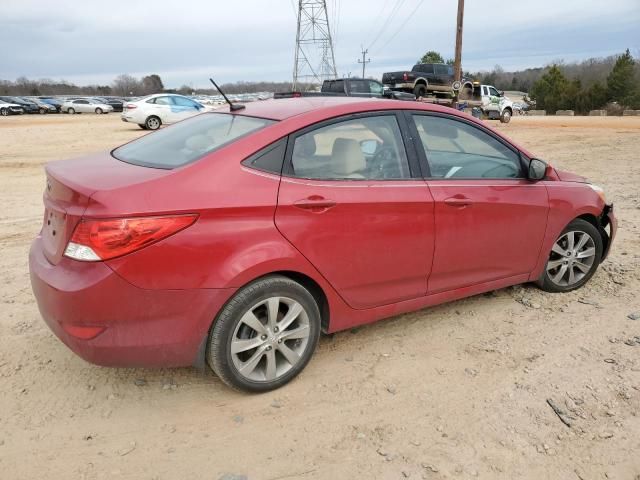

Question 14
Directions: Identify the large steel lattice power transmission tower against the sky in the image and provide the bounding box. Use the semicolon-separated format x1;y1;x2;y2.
293;0;338;90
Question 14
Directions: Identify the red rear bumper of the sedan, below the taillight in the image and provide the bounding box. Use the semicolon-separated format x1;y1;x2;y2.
29;236;235;367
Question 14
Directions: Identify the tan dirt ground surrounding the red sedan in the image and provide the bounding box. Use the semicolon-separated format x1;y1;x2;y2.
0;114;640;480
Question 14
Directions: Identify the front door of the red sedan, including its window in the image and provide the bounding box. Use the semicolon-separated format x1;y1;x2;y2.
408;112;549;293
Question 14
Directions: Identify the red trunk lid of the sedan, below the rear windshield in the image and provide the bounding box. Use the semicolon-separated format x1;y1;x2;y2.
41;152;170;265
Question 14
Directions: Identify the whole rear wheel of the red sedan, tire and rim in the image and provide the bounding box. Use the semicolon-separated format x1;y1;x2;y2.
207;275;320;392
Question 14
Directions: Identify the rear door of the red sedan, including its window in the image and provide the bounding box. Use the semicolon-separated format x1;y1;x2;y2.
275;112;434;309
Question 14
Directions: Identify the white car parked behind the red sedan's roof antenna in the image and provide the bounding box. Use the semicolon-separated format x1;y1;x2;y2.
120;93;211;130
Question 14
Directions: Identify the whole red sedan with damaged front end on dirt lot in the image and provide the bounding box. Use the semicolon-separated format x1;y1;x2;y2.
29;98;616;391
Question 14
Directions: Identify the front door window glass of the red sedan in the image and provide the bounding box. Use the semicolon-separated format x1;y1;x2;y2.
413;115;522;178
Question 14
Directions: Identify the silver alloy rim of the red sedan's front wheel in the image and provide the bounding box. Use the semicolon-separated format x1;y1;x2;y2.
546;231;596;287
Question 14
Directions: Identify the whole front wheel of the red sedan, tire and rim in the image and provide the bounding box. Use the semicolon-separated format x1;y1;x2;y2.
536;218;603;293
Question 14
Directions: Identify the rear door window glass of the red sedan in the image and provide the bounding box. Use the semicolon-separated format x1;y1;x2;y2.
291;115;410;180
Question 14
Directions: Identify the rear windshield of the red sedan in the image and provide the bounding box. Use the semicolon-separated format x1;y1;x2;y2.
111;113;275;169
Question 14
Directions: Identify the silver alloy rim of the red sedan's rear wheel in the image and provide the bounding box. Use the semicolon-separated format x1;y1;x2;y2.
230;297;310;382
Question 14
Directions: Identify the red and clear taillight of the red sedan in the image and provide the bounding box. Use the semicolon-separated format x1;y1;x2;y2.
64;215;198;262
